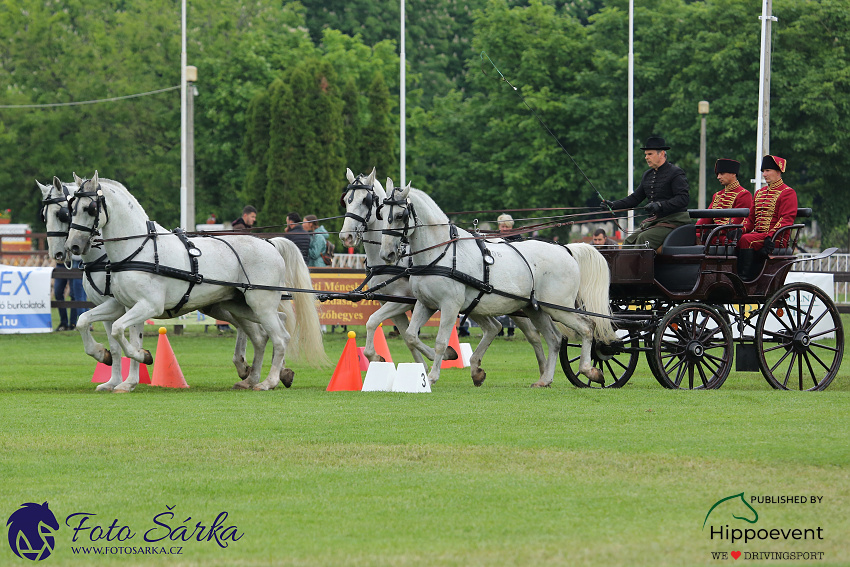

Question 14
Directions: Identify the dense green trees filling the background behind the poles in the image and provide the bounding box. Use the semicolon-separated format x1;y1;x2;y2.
0;0;850;244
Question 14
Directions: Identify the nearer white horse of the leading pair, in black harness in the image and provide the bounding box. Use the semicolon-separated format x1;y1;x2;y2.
66;173;328;390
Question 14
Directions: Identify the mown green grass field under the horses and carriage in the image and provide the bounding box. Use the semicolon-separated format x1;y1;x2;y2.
0;322;850;567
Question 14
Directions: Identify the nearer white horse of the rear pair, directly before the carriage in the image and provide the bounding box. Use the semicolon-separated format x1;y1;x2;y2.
381;179;617;387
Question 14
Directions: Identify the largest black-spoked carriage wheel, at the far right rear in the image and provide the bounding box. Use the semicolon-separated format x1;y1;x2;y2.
756;283;844;390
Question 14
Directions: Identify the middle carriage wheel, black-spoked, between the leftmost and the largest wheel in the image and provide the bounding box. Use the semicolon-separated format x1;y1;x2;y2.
647;303;733;390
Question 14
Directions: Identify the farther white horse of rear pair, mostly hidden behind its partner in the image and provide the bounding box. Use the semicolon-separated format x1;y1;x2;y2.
339;168;546;386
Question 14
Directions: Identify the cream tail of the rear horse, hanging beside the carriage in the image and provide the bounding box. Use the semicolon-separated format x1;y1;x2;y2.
567;242;617;344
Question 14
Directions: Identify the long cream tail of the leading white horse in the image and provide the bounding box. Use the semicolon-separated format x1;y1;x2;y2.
269;237;330;366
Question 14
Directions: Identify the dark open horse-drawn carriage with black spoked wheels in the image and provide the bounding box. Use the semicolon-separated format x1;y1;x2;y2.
560;209;844;390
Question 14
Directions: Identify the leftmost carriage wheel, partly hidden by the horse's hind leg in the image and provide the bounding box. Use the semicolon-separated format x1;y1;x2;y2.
560;331;640;388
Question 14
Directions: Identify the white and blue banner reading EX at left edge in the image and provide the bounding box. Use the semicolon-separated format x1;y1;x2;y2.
0;264;53;334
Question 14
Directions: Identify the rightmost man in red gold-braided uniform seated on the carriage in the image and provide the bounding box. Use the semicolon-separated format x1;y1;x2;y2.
738;155;797;280
